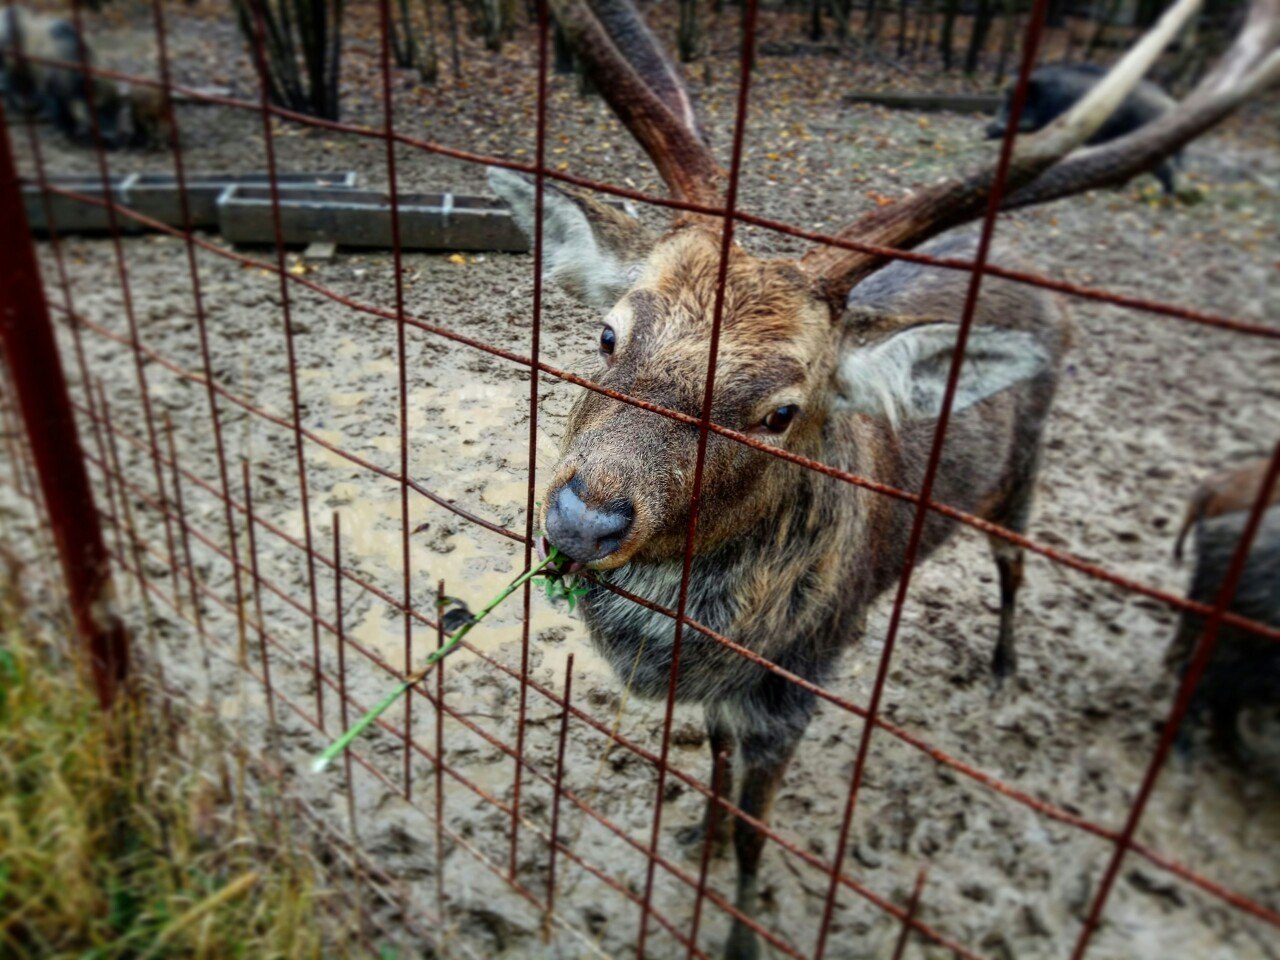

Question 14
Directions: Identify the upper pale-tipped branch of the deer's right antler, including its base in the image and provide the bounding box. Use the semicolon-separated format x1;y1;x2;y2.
801;0;1203;303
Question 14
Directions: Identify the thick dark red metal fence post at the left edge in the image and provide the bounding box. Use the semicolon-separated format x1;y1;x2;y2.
0;105;129;708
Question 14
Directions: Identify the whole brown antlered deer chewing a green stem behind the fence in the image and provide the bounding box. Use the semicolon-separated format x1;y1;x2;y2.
489;0;1280;960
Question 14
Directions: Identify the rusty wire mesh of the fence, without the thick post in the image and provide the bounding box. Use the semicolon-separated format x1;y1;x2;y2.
0;0;1280;959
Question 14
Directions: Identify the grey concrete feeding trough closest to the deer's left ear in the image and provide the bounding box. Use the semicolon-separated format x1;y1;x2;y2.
219;186;529;252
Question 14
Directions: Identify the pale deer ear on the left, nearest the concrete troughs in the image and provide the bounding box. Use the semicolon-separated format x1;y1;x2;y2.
489;166;653;307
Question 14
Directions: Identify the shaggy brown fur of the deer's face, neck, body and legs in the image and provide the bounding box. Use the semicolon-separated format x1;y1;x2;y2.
493;173;1068;957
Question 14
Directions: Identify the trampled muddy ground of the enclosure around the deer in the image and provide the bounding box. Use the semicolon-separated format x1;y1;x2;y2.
0;1;1280;960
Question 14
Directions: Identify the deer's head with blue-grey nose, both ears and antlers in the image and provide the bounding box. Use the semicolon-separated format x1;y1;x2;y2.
490;0;1280;570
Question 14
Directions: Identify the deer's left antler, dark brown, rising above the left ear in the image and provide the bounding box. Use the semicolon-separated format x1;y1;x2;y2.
550;0;724;206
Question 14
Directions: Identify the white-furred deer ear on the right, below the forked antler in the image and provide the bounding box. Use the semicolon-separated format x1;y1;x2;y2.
836;323;1050;428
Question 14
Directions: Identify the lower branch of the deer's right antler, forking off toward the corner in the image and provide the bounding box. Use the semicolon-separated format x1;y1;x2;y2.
1005;0;1280;209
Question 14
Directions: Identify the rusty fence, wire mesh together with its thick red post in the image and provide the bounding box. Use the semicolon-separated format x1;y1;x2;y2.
0;0;1280;957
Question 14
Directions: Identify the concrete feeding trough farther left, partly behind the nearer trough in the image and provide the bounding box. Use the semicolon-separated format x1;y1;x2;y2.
23;170;356;233
